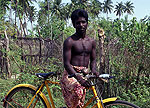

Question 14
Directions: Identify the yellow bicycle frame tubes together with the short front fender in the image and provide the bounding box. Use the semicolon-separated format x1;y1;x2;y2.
27;80;117;108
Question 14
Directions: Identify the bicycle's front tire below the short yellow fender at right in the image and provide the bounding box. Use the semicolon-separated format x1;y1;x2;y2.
104;100;140;108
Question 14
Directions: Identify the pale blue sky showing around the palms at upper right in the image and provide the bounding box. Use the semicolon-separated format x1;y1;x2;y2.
62;0;150;20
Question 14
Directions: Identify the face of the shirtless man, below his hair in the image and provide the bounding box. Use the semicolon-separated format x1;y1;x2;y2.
74;17;88;34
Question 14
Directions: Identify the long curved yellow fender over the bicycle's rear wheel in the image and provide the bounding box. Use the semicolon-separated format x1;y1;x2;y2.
4;84;51;108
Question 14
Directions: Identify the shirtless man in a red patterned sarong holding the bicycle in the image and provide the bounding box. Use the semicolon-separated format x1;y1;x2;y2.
61;9;98;108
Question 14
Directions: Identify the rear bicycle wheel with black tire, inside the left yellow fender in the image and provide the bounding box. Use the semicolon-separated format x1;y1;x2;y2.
4;86;47;108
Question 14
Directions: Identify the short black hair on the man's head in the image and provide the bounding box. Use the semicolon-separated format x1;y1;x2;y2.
71;9;88;26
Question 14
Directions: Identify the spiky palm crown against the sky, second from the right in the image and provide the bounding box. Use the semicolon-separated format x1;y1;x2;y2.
114;2;125;19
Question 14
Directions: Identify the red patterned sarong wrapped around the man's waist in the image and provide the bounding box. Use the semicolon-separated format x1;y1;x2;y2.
61;66;86;108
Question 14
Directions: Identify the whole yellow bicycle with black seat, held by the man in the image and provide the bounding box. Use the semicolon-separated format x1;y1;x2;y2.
3;72;140;108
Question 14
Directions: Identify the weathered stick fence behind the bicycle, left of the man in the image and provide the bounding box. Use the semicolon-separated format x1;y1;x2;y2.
0;37;62;77
